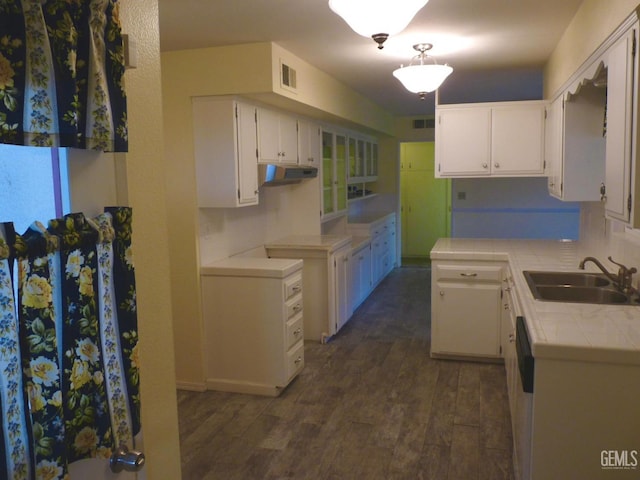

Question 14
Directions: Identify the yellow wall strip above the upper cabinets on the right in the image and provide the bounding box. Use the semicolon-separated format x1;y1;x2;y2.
544;0;638;98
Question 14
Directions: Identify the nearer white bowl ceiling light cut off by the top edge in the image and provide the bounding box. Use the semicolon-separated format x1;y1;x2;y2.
329;0;429;49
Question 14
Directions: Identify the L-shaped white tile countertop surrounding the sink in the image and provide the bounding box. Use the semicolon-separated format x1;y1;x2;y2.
431;238;640;365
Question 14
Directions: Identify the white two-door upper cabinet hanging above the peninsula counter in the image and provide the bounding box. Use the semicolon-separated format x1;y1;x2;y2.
436;101;545;177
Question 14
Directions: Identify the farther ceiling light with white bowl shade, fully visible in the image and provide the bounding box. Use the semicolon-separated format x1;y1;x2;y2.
393;43;453;100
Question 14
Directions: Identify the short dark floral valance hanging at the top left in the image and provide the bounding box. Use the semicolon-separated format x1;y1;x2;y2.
0;0;128;152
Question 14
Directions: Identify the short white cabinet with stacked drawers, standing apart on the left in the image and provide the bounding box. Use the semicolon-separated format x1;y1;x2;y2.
201;258;304;396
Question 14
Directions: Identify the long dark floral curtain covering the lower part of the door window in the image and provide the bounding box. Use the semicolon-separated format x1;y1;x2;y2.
0;207;140;480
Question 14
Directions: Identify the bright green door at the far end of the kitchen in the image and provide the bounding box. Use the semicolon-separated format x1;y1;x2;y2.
400;142;451;259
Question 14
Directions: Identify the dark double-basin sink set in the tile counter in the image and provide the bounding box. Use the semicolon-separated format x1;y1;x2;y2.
523;270;640;305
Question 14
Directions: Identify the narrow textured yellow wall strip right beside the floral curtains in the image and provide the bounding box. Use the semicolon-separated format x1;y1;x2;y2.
120;0;181;480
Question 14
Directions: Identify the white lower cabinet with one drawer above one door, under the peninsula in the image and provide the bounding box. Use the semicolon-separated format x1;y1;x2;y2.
431;261;503;358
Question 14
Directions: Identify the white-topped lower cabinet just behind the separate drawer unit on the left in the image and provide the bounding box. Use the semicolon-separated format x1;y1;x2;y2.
265;235;351;343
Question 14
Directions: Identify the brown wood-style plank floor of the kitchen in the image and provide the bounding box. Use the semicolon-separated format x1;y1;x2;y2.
178;267;513;480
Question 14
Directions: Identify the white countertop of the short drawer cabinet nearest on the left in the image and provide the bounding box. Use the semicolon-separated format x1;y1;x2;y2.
200;257;303;278
